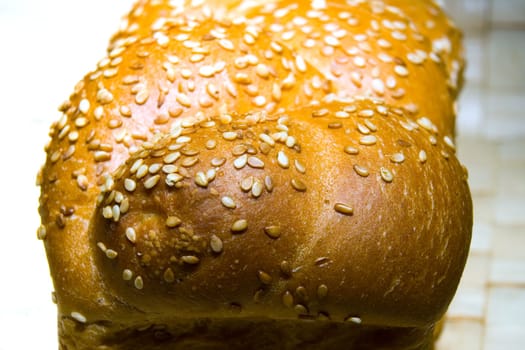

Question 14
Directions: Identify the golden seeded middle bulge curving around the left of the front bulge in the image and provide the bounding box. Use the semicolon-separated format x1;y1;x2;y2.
39;7;328;320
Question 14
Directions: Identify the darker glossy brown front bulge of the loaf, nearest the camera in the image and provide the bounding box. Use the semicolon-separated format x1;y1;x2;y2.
92;101;471;326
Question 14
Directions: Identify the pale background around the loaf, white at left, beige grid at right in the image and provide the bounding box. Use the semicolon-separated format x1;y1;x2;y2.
0;0;525;350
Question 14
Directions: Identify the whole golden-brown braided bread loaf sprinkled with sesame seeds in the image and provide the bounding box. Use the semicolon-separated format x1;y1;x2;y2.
38;0;472;350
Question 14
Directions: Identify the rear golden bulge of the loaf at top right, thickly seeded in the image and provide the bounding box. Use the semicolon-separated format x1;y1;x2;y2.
237;0;463;137
